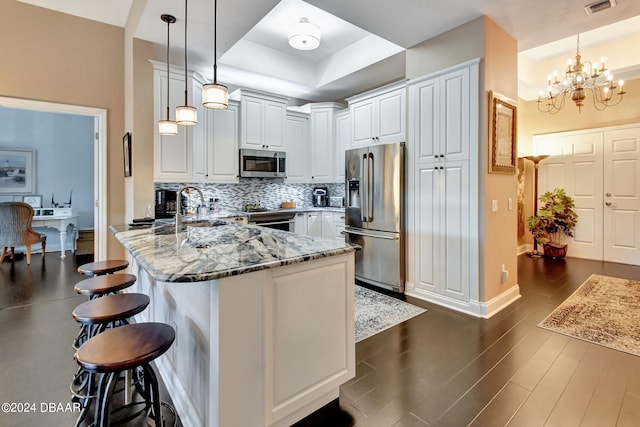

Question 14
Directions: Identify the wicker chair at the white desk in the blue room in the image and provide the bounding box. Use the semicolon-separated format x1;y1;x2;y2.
0;202;47;264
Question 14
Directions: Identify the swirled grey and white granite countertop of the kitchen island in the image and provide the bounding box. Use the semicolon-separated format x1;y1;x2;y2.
110;219;356;282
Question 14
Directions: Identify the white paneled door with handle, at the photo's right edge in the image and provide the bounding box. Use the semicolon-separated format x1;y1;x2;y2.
603;127;640;265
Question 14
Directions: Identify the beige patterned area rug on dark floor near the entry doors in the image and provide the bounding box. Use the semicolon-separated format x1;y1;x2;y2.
538;274;640;356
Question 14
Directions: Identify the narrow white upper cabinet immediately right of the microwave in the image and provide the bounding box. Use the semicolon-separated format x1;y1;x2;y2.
283;111;311;183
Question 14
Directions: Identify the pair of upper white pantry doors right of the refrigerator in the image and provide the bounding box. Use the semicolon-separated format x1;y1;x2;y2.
409;67;475;162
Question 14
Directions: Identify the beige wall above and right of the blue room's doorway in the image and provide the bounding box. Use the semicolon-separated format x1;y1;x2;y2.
0;0;124;257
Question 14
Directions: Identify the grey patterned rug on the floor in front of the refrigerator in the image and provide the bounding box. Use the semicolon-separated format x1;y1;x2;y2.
355;285;427;342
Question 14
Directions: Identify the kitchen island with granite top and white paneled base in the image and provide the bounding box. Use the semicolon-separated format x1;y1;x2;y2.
111;220;355;427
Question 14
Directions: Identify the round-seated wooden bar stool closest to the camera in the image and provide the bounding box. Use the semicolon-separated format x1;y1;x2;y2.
76;323;176;427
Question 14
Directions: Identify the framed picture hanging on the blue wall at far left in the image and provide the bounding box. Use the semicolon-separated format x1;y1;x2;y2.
0;148;36;194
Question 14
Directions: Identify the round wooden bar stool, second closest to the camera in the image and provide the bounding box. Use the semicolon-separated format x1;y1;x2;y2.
70;293;149;418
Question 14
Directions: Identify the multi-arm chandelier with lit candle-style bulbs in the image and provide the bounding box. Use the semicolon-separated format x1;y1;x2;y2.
538;34;626;114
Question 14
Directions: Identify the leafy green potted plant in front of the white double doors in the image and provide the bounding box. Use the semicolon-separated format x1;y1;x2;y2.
527;188;578;258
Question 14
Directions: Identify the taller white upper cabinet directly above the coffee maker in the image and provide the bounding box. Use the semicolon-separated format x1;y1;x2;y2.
310;102;343;182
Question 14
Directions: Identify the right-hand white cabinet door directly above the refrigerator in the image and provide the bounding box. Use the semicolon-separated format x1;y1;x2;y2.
375;88;406;144
